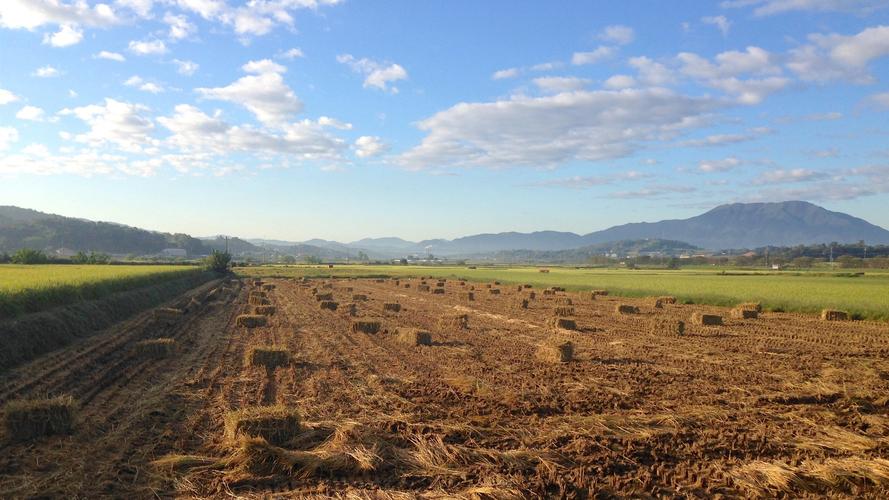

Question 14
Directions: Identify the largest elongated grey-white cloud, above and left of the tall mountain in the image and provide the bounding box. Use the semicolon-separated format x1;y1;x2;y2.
397;88;717;169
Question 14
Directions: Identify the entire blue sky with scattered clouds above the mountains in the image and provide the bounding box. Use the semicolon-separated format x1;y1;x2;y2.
0;0;889;241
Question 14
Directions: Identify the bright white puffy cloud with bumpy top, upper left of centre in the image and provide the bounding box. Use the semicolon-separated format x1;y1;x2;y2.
195;59;303;125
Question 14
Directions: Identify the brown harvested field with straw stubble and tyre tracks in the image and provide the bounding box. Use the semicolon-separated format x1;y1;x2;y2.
0;279;889;498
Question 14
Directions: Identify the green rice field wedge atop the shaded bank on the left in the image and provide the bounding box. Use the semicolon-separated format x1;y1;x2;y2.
0;264;201;319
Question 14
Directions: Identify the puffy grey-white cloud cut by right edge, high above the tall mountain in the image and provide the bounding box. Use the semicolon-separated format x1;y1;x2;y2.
787;26;889;83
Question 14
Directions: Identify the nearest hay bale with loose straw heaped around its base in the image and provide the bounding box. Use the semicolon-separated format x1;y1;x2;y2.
225;405;301;446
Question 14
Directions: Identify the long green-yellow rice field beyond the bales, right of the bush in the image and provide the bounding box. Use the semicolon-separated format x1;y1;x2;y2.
236;265;889;321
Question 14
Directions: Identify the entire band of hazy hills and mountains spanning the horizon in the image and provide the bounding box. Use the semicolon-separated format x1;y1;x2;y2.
0;201;889;259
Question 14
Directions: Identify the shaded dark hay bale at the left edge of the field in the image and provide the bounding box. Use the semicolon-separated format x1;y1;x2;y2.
2;396;77;441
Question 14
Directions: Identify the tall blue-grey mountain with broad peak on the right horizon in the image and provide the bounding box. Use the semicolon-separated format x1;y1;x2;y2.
583;201;889;250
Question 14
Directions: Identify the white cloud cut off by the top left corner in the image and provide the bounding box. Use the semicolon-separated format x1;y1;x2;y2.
0;0;120;31
